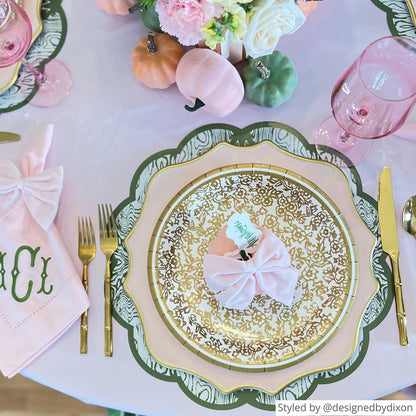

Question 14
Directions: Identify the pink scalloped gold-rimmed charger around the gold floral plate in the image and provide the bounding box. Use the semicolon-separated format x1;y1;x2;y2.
124;142;378;394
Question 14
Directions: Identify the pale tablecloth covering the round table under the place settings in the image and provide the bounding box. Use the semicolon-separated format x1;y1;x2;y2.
0;0;416;416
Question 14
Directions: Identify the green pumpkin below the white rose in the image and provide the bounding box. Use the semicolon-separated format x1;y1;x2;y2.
242;51;298;107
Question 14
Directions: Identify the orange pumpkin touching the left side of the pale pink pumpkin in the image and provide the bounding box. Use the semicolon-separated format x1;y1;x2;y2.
131;33;184;89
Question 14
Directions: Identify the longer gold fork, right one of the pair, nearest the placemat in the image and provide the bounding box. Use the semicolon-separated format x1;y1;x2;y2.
98;204;118;357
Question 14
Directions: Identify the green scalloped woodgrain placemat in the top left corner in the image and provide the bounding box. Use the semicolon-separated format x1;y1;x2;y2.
0;0;67;115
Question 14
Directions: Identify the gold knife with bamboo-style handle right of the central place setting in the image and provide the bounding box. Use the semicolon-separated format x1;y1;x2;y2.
378;167;408;345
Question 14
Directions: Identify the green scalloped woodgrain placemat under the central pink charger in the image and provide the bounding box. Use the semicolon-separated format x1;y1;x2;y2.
111;122;393;410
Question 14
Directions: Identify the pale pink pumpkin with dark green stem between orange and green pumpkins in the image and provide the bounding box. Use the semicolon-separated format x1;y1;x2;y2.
176;48;244;117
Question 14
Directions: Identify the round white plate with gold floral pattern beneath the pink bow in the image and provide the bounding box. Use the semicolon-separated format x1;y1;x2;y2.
148;165;358;371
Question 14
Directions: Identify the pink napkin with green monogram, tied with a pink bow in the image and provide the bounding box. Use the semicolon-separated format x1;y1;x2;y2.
0;125;89;377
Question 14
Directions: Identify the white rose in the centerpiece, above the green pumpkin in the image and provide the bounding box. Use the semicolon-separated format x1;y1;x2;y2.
243;0;306;58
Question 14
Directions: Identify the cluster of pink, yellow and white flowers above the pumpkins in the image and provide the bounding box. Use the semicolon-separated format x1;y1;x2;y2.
150;0;305;58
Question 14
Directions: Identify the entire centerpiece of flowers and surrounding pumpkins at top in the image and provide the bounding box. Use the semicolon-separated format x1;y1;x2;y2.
95;0;319;116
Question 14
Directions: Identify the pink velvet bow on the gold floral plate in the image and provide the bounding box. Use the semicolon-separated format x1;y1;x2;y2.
204;231;298;309
